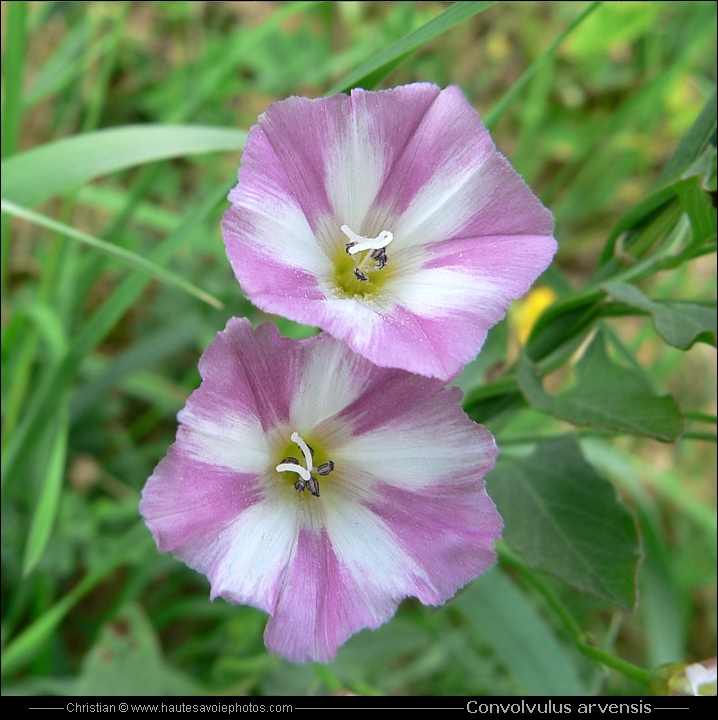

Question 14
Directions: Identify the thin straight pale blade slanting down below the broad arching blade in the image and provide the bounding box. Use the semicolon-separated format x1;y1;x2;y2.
0;198;222;309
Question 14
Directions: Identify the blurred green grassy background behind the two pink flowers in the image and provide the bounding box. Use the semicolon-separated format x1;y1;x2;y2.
2;2;716;695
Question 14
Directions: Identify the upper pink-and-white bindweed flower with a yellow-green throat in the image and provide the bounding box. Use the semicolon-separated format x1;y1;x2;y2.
222;84;556;380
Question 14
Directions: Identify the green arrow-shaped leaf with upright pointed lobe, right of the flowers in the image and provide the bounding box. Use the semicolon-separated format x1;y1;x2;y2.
517;331;683;442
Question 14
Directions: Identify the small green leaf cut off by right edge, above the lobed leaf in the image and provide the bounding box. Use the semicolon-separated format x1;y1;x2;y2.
602;282;717;350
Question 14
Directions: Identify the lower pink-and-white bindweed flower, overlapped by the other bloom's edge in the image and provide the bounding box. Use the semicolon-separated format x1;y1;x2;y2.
140;319;502;662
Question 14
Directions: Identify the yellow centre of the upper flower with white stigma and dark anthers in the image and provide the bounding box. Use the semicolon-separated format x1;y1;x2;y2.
333;225;394;298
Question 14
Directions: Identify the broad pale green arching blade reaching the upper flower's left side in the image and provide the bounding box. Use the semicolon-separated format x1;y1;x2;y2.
0;125;247;205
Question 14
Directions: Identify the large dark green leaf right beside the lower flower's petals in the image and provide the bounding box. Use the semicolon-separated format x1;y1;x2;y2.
487;436;640;610
